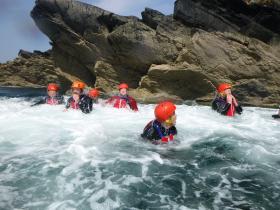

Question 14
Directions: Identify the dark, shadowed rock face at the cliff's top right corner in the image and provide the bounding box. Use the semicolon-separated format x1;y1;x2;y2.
174;0;280;42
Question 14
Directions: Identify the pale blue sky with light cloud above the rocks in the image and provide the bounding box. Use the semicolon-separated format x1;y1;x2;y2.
0;0;175;63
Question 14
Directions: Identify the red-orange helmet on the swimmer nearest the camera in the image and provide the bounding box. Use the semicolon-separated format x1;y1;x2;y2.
155;101;176;122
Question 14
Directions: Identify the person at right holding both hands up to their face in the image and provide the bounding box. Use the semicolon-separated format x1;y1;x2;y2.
212;83;243;117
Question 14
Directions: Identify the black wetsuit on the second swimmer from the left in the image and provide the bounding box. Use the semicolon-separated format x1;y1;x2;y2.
66;95;93;114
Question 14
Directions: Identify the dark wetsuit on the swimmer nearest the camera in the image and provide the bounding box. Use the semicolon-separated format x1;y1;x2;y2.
141;120;177;141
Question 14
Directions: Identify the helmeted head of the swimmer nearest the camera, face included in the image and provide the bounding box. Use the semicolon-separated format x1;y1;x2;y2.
155;101;177;128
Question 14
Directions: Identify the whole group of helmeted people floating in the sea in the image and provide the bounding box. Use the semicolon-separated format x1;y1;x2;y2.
32;81;280;144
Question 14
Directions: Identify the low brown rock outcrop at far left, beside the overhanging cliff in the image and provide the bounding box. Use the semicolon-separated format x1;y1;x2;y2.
0;50;77;91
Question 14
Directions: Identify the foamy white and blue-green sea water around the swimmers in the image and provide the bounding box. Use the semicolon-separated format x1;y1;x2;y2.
0;98;280;210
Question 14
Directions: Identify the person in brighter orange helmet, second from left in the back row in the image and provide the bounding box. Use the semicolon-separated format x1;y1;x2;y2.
66;81;92;114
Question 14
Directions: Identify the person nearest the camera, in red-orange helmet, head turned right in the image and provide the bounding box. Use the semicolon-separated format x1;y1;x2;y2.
141;101;177;144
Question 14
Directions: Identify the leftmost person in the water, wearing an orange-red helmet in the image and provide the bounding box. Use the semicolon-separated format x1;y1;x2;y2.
32;83;64;106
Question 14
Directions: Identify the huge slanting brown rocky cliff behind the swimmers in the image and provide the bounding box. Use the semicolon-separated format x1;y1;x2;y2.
0;0;280;106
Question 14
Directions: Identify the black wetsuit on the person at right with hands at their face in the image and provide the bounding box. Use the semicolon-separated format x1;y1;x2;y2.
212;96;243;115
